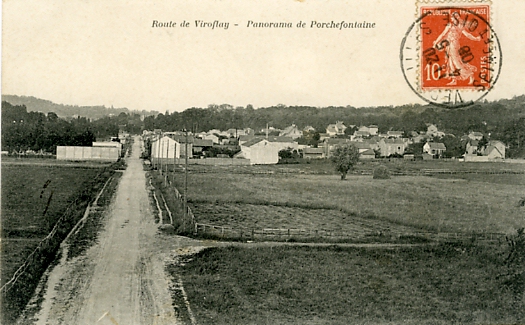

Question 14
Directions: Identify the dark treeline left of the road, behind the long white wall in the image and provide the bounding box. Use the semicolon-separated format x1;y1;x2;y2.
2;101;119;153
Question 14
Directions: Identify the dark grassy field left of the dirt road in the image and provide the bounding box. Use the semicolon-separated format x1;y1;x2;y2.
1;162;112;320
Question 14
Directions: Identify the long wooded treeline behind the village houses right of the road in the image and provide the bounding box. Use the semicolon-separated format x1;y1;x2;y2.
144;96;525;157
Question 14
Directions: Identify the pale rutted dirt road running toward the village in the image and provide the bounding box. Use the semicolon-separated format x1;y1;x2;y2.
32;138;180;325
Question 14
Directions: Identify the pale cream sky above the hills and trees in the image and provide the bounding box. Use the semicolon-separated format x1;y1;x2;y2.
2;0;525;112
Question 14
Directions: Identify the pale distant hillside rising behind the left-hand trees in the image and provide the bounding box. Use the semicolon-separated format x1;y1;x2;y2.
2;95;158;119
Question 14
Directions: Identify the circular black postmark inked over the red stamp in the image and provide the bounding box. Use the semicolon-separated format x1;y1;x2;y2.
399;5;502;108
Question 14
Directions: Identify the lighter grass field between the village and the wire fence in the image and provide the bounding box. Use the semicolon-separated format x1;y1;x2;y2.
169;162;525;233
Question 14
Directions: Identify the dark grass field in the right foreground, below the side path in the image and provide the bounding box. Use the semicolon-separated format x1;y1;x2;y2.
168;244;525;325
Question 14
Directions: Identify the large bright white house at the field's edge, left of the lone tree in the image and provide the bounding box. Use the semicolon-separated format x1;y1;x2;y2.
234;137;297;165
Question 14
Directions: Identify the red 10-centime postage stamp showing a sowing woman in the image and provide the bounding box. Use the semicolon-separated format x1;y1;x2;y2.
419;5;492;91
